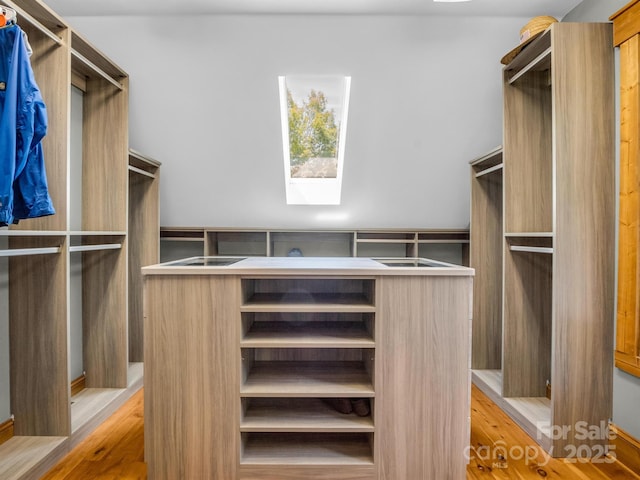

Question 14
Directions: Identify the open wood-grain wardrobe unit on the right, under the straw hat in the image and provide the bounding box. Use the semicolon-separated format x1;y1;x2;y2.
471;23;615;458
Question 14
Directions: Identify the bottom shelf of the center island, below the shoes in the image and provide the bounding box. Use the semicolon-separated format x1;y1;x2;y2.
240;433;373;468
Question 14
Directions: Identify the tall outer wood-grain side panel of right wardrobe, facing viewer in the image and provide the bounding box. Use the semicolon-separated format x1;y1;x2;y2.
551;23;616;456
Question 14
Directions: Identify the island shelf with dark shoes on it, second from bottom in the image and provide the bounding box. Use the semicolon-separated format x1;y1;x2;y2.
240;398;374;433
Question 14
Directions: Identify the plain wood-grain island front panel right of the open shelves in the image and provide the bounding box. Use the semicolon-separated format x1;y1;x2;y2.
376;276;472;480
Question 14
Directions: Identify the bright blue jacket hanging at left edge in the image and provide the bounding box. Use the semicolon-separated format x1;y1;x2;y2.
0;25;55;225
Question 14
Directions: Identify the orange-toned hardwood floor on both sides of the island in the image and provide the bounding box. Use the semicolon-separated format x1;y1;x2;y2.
41;387;640;480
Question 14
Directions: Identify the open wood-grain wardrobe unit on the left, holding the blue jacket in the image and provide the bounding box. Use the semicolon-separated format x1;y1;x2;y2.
0;0;159;480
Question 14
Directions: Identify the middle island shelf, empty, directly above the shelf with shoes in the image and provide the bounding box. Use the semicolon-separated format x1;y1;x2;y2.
240;361;374;398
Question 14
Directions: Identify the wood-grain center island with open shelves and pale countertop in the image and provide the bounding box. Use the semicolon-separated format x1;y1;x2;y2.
142;257;474;480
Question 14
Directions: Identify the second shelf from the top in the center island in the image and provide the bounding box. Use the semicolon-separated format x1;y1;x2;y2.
240;321;375;348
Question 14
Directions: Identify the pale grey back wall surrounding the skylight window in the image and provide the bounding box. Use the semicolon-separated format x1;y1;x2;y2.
68;15;525;228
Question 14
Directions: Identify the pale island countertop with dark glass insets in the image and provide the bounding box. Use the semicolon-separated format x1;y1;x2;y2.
142;256;475;276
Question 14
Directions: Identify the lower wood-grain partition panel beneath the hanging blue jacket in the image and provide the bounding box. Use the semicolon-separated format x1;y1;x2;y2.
9;237;71;436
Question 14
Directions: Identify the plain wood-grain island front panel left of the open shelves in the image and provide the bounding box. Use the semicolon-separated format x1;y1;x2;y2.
144;275;240;480
